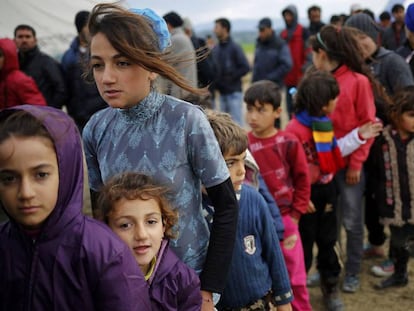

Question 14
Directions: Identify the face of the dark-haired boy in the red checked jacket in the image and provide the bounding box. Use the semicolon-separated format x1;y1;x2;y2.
246;102;282;137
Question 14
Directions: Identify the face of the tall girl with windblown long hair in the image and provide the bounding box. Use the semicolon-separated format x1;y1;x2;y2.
91;33;156;108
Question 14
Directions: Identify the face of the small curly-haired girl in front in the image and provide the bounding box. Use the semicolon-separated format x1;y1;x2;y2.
108;198;165;274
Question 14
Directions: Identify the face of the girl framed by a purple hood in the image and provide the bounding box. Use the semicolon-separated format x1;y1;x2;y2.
0;136;59;230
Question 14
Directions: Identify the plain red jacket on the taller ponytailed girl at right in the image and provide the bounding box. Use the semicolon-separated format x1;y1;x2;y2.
330;65;375;170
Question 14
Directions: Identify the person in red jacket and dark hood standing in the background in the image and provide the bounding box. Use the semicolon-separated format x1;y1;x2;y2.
280;4;309;118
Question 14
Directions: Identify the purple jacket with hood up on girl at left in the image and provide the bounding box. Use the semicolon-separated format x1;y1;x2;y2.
0;105;151;311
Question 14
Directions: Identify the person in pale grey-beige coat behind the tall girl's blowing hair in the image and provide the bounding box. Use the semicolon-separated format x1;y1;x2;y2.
160;11;198;99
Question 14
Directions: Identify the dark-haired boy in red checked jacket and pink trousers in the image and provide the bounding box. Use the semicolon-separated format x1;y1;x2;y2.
244;80;312;311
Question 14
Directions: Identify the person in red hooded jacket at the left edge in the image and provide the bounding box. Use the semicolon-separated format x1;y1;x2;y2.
0;38;46;109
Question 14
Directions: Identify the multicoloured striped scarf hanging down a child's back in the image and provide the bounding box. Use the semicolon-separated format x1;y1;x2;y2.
296;111;345;174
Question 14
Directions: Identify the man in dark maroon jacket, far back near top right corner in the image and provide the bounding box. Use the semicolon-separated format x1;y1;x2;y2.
381;4;405;50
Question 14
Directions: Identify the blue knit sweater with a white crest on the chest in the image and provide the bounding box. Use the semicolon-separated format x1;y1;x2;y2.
219;185;293;308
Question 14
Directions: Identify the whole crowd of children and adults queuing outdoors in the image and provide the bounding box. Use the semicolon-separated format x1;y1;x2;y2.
0;3;414;311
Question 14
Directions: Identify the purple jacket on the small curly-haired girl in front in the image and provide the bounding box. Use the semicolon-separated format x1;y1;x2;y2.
148;240;201;311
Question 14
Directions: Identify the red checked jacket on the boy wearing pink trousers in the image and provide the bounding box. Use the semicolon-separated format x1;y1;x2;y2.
248;131;310;219
